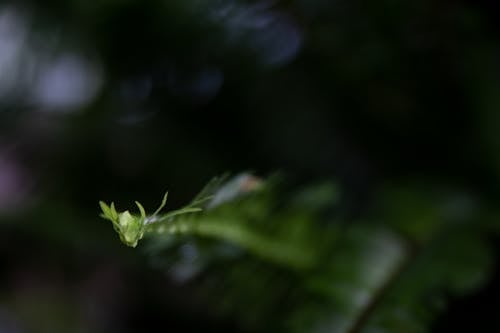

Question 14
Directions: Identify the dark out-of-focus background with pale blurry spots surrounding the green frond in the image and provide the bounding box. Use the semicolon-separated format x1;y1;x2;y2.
0;0;500;333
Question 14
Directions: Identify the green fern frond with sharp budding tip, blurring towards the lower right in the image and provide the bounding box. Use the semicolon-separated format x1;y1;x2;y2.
102;174;492;333
